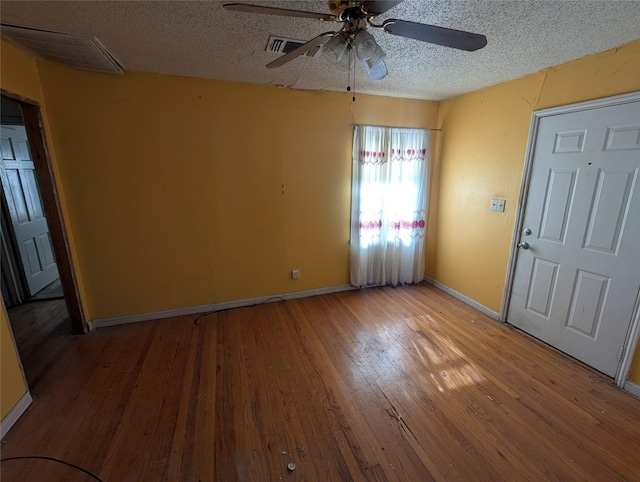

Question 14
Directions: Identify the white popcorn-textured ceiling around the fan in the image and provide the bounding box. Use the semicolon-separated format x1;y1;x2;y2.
0;0;640;100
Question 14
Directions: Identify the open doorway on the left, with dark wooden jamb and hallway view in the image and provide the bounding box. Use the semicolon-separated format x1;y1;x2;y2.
0;90;88;388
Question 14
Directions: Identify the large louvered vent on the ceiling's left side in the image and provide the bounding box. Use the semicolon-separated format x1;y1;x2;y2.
0;24;124;74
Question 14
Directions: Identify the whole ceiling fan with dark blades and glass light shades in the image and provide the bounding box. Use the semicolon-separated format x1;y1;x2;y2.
223;0;487;80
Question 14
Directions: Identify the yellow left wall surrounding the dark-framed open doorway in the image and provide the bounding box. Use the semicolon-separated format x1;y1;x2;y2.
0;42;42;419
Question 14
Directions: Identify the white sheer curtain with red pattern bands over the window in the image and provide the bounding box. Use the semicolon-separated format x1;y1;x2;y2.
351;126;429;287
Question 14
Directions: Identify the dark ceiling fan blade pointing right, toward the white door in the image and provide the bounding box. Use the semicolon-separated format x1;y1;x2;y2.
382;19;487;51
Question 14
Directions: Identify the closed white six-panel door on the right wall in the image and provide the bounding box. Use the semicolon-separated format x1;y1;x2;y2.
507;97;640;376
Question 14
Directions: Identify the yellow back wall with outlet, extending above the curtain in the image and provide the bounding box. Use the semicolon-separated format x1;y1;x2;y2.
35;64;438;319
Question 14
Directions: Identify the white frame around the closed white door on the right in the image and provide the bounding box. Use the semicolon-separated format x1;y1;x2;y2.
500;91;640;387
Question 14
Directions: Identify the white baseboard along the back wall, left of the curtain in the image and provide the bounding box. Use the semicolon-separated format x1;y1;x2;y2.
88;285;357;330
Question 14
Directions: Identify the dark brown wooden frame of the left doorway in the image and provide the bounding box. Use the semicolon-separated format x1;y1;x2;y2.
0;89;89;334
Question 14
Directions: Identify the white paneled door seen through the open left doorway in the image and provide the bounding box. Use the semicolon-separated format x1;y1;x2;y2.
0;126;58;296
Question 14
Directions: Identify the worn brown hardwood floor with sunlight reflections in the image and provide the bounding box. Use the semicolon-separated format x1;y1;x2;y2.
2;285;640;482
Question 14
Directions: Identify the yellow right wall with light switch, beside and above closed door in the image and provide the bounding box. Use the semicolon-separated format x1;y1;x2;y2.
426;41;640;382
